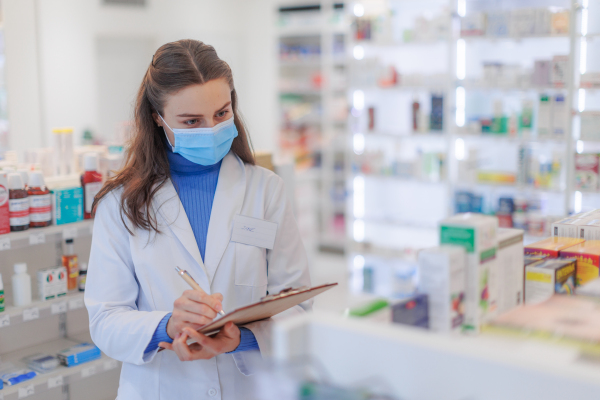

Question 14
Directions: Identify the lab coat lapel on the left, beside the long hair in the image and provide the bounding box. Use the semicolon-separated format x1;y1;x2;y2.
156;179;210;286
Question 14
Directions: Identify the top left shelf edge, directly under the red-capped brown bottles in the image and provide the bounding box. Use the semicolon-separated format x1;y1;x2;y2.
0;219;94;251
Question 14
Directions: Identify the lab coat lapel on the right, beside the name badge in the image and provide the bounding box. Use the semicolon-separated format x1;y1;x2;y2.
204;152;246;282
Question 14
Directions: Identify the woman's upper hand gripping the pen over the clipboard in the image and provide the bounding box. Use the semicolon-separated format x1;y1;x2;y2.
167;290;223;339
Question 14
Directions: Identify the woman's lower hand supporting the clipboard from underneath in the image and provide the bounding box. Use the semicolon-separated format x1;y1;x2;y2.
159;322;240;361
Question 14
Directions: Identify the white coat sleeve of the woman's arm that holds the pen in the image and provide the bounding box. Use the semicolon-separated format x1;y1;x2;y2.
84;193;167;365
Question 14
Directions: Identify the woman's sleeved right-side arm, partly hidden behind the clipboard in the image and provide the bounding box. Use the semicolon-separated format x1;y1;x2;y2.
233;176;312;374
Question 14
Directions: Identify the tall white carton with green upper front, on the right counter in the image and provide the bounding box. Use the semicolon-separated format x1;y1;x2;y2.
440;213;498;333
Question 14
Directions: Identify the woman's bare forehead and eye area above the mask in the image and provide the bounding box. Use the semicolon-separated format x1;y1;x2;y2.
165;78;231;115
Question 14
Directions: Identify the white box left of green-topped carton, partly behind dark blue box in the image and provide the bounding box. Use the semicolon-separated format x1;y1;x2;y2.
418;246;466;332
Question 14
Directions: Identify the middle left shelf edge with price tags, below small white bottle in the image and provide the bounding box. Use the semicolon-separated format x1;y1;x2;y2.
0;292;84;332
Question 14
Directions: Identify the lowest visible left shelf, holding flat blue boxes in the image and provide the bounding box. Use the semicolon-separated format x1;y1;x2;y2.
0;333;121;400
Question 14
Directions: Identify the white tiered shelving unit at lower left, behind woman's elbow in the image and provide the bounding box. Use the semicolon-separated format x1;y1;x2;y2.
0;220;121;400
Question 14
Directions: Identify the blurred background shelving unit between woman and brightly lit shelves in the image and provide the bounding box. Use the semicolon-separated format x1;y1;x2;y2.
278;1;349;254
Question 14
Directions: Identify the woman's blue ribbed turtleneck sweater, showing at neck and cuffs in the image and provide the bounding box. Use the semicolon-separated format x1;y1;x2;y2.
145;143;258;353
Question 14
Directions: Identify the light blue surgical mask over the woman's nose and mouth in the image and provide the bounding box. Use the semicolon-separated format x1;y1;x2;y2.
158;114;238;165
